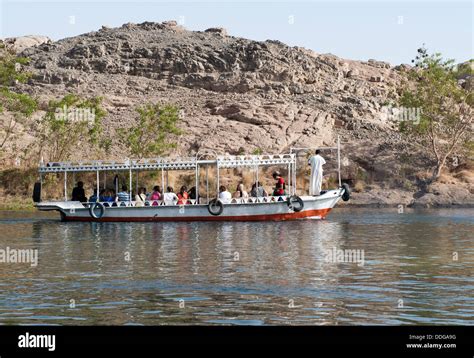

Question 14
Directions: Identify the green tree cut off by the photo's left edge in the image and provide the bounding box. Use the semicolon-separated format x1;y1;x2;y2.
0;43;38;150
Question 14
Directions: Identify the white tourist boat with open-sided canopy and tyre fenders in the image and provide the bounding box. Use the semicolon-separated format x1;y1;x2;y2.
33;144;349;222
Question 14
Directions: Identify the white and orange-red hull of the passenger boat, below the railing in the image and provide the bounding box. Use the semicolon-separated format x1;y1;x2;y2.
36;188;344;222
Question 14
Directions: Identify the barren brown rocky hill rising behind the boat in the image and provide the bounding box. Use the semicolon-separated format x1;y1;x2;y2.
1;21;473;207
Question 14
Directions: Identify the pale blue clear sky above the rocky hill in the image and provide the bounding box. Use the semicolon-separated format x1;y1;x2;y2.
0;0;474;65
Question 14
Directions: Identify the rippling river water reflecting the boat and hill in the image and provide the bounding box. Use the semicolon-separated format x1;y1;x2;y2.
0;209;474;325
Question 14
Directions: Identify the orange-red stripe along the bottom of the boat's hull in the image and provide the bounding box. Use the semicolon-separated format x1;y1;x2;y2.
64;208;331;222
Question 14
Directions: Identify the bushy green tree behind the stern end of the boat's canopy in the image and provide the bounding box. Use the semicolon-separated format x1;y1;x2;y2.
37;94;109;161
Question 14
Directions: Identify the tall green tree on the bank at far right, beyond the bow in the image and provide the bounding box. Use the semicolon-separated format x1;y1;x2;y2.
399;48;473;181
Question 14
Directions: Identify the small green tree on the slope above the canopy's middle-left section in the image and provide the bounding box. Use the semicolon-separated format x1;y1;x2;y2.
118;103;181;159
